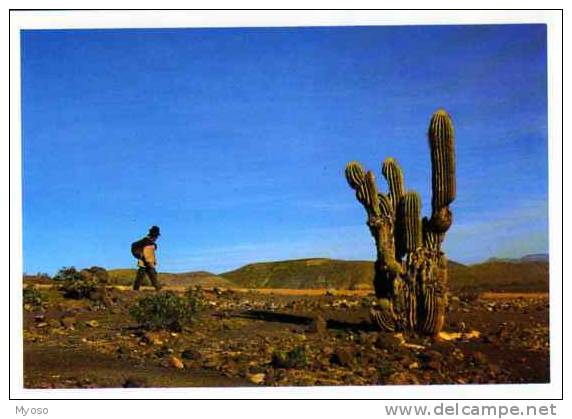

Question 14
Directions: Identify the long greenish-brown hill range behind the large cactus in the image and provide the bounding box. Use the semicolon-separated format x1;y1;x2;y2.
219;254;548;292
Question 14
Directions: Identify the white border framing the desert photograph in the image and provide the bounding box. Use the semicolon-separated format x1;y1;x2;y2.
10;10;562;402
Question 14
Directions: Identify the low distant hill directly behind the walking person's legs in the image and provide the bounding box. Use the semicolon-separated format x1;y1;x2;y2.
107;269;234;288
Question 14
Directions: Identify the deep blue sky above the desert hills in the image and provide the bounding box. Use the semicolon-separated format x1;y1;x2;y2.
22;25;548;273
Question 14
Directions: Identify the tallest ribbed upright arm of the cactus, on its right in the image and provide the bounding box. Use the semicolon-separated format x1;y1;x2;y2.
429;109;456;213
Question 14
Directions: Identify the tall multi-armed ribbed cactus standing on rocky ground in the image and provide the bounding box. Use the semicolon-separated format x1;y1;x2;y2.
346;109;456;335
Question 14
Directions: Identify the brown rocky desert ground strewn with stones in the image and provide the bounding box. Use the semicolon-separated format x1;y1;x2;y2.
24;285;550;388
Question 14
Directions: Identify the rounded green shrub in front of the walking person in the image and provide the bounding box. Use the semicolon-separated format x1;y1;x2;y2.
129;291;203;332
